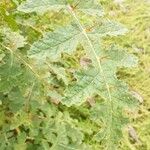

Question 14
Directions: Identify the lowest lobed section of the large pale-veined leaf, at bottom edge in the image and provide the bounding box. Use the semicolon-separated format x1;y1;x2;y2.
91;103;128;150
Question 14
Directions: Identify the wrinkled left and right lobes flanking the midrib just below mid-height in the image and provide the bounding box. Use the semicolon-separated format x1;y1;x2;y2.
62;64;136;107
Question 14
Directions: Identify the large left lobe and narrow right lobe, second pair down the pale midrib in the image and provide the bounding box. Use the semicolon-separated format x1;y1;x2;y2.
28;21;126;61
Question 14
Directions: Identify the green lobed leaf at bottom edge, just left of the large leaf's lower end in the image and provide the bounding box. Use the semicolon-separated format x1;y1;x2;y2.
43;112;86;150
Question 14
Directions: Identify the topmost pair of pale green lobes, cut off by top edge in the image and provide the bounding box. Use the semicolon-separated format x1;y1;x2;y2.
18;0;104;16
